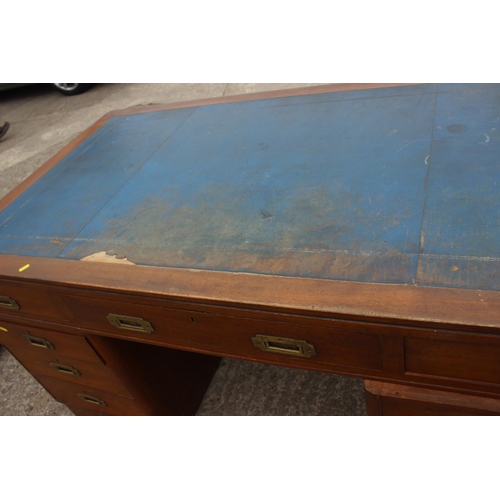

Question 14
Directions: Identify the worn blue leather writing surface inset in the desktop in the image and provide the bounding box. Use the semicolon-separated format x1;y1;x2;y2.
0;84;500;290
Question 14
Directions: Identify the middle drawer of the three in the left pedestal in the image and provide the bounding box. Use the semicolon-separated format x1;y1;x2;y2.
5;344;132;397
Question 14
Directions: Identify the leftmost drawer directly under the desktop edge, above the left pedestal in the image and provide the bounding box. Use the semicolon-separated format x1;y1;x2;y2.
0;280;68;323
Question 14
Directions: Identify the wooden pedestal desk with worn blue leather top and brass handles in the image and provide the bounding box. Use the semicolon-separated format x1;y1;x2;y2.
0;85;500;415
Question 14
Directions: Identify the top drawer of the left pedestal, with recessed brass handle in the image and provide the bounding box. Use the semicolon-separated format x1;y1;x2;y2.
0;320;102;363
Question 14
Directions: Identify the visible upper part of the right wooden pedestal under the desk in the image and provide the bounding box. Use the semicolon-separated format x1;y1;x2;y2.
365;380;500;416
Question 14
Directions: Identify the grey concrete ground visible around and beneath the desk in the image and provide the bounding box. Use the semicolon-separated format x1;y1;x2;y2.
0;83;365;415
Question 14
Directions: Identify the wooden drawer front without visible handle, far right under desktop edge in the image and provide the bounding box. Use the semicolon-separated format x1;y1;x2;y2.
405;334;500;384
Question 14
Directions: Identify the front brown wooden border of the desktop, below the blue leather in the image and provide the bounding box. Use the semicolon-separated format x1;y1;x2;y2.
0;255;500;334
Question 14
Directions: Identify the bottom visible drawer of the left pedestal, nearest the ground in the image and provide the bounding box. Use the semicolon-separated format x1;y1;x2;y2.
35;375;148;415
